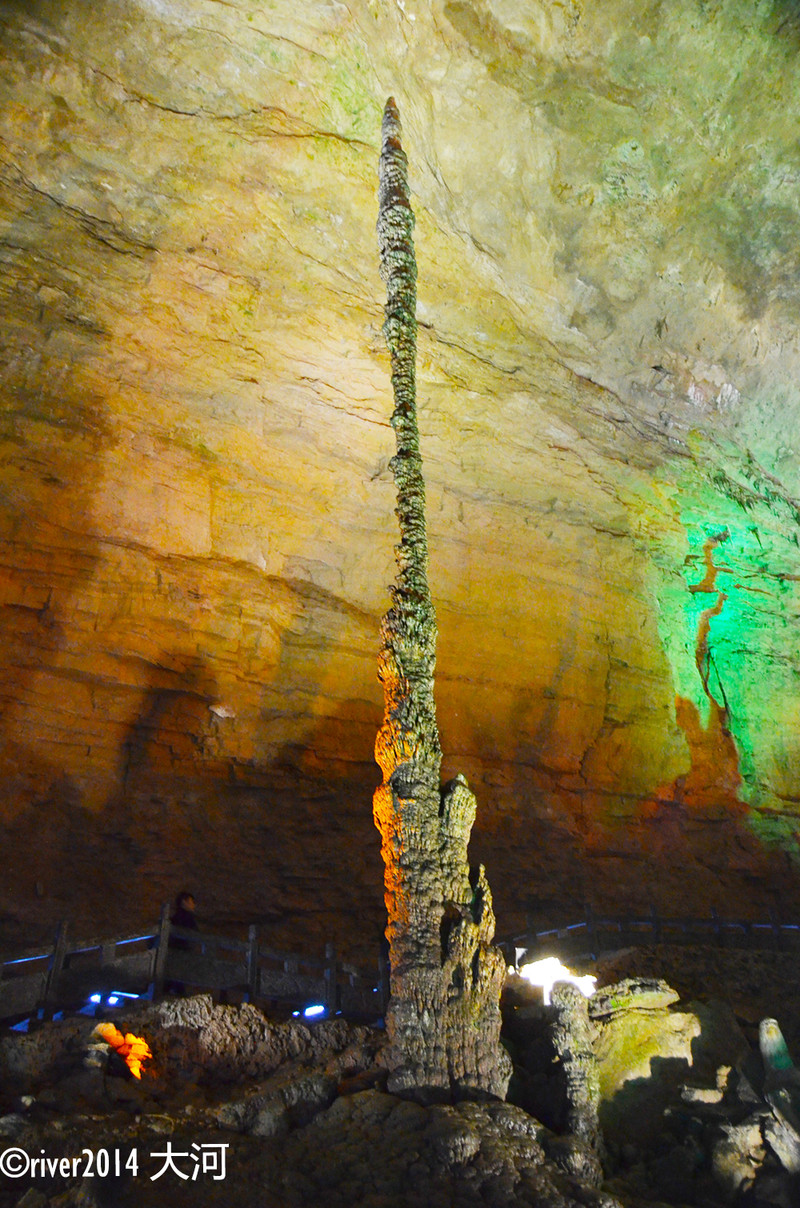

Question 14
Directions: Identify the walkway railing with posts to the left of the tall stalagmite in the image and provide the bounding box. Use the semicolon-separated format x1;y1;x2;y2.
0;906;388;1021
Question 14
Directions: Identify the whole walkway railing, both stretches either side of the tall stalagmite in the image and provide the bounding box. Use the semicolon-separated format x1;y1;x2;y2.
7;906;800;1022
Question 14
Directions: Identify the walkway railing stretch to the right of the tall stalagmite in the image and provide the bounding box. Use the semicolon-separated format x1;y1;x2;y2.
502;906;800;960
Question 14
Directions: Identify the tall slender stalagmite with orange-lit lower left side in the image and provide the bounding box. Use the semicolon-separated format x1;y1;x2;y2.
373;98;510;1099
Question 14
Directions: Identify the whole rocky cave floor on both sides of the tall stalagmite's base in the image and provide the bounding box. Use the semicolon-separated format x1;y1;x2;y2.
0;947;800;1208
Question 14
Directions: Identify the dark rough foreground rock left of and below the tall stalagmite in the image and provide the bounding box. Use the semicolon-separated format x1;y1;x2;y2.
0;995;619;1208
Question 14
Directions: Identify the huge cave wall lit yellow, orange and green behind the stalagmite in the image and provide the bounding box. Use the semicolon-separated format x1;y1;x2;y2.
0;0;800;949
